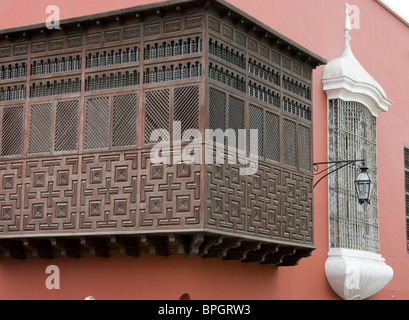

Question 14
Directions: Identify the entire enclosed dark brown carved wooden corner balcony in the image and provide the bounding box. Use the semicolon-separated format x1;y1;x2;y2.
0;0;325;266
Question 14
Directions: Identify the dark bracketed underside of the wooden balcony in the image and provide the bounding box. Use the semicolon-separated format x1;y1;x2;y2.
0;232;314;267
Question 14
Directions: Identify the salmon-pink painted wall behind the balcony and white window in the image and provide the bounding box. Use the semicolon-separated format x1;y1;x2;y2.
0;0;409;299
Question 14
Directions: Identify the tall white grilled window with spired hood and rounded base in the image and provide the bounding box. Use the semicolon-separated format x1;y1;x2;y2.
322;5;393;300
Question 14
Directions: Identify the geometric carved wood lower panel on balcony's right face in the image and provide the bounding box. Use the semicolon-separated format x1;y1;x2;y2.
206;162;313;244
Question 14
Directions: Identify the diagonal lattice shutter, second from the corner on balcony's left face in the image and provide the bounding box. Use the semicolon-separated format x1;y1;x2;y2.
144;90;171;144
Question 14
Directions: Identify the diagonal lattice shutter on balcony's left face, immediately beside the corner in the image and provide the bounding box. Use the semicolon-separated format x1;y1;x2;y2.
173;86;200;141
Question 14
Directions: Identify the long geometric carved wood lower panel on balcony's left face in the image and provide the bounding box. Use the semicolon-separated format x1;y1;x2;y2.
0;152;201;235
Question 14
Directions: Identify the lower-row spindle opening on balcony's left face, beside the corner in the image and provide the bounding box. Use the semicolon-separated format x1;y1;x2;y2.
144;61;202;84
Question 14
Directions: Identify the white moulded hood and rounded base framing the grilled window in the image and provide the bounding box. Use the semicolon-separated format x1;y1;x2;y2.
322;4;393;300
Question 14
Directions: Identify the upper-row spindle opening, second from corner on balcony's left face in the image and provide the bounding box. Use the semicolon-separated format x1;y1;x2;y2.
86;46;140;69
